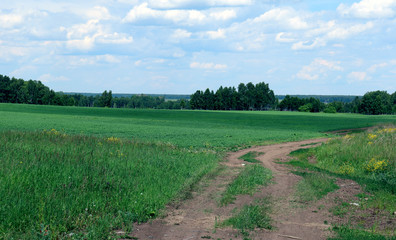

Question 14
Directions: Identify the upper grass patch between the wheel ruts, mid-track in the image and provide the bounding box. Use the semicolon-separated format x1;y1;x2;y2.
220;164;272;206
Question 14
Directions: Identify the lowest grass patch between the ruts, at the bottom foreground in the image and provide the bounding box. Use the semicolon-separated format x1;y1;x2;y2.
219;198;274;237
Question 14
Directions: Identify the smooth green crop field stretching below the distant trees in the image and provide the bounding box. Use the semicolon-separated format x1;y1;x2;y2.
0;104;396;150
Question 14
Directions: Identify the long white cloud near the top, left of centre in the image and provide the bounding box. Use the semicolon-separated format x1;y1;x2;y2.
123;3;236;26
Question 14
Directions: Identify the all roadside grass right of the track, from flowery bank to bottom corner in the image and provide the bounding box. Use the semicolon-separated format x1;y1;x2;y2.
288;125;396;239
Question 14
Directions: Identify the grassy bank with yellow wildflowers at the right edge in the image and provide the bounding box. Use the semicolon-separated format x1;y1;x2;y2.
315;126;396;194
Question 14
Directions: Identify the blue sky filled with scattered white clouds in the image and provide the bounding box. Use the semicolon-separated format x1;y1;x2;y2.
0;0;396;95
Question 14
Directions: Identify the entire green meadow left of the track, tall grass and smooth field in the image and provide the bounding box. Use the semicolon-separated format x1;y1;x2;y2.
0;104;396;239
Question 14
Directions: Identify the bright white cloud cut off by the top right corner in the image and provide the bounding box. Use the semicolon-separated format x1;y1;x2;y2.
337;0;396;18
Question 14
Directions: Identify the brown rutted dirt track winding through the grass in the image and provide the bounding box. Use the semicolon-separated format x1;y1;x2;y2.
131;139;360;240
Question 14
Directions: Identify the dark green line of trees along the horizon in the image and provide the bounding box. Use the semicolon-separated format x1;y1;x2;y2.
0;75;396;115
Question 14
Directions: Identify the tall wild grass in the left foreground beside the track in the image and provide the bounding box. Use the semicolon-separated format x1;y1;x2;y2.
0;129;219;239
